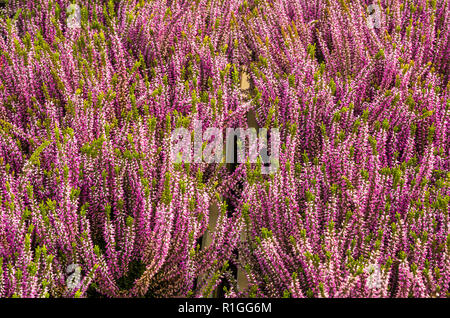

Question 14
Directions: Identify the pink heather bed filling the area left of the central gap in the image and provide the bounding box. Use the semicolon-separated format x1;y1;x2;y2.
1;1;244;297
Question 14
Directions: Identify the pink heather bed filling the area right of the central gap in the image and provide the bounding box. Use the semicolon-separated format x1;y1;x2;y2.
232;1;450;297
